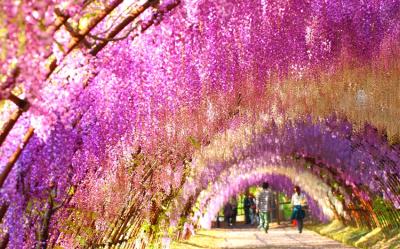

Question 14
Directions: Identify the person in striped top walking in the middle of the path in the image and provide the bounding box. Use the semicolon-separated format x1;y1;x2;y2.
257;182;272;233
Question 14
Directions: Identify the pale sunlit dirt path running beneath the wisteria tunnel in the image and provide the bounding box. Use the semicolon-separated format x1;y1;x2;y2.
172;224;353;249
